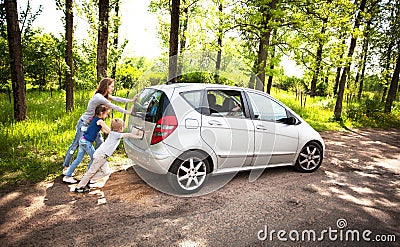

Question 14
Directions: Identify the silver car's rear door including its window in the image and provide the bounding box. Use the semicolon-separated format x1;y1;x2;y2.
201;89;254;170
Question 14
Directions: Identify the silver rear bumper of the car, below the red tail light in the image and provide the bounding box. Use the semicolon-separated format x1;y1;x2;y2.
124;139;177;174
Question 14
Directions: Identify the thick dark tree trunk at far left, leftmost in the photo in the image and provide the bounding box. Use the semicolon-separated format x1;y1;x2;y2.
4;0;28;121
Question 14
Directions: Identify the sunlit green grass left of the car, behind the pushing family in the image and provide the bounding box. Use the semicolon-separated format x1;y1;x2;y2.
0;90;130;188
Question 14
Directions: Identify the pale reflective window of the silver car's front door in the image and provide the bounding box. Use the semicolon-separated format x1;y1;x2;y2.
248;92;287;122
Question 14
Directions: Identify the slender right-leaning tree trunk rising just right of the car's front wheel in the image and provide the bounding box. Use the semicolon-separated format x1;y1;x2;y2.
334;0;366;120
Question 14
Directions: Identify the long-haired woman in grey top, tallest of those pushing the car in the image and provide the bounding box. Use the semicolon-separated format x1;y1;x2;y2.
63;78;138;175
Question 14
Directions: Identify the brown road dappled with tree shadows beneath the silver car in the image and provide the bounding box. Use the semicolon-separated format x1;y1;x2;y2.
0;130;400;246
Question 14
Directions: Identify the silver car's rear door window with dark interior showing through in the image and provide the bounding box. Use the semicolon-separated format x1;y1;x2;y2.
207;90;244;118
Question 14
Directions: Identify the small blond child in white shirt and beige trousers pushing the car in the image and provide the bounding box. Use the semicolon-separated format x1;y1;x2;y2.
75;118;140;193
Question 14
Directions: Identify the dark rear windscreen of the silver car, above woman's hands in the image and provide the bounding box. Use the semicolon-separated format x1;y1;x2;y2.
133;88;175;123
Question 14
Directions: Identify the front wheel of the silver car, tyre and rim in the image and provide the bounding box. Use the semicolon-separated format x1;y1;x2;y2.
294;142;323;172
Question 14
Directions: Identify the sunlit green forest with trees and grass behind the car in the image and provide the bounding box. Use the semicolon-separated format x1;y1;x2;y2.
0;0;400;186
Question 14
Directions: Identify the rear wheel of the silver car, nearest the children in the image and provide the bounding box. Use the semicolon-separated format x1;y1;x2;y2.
167;151;210;194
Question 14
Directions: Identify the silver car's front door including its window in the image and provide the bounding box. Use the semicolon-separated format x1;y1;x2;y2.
247;91;299;166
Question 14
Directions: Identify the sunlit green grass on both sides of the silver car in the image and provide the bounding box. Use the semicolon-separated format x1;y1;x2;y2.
0;90;400;188
